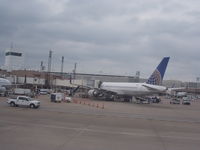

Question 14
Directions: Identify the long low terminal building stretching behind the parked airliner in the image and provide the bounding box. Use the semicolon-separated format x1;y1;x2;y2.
0;70;200;94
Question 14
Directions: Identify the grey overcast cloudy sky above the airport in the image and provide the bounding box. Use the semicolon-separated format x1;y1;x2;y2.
0;0;200;81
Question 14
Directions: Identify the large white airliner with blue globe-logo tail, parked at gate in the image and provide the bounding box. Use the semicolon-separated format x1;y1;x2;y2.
88;57;170;99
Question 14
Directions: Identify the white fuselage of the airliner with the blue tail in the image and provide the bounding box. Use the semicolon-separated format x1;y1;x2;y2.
100;82;167;96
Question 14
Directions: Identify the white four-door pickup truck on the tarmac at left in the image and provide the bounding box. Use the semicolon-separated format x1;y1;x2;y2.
7;96;40;108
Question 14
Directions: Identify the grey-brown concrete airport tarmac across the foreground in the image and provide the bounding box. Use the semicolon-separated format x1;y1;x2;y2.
0;96;200;150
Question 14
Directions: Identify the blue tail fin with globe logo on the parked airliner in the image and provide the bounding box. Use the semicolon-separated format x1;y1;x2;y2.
147;57;169;85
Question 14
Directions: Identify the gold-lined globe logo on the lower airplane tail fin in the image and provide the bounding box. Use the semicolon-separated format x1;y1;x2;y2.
147;69;162;85
